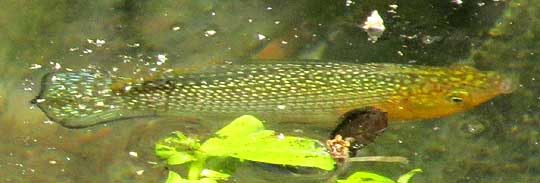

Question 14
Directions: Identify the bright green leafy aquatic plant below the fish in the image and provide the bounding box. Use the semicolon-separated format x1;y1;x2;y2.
155;115;421;183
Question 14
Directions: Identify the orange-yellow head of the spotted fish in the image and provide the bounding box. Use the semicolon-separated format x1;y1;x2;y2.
383;66;517;120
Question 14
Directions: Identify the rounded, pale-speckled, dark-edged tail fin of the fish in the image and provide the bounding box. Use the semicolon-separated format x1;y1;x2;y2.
32;72;152;128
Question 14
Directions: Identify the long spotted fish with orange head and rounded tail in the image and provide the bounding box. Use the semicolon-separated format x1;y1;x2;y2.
32;60;517;128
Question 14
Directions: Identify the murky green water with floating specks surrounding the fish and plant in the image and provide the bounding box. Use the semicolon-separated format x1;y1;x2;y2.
0;0;540;183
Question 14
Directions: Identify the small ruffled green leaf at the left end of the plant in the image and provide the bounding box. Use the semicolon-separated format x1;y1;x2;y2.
155;132;200;165
